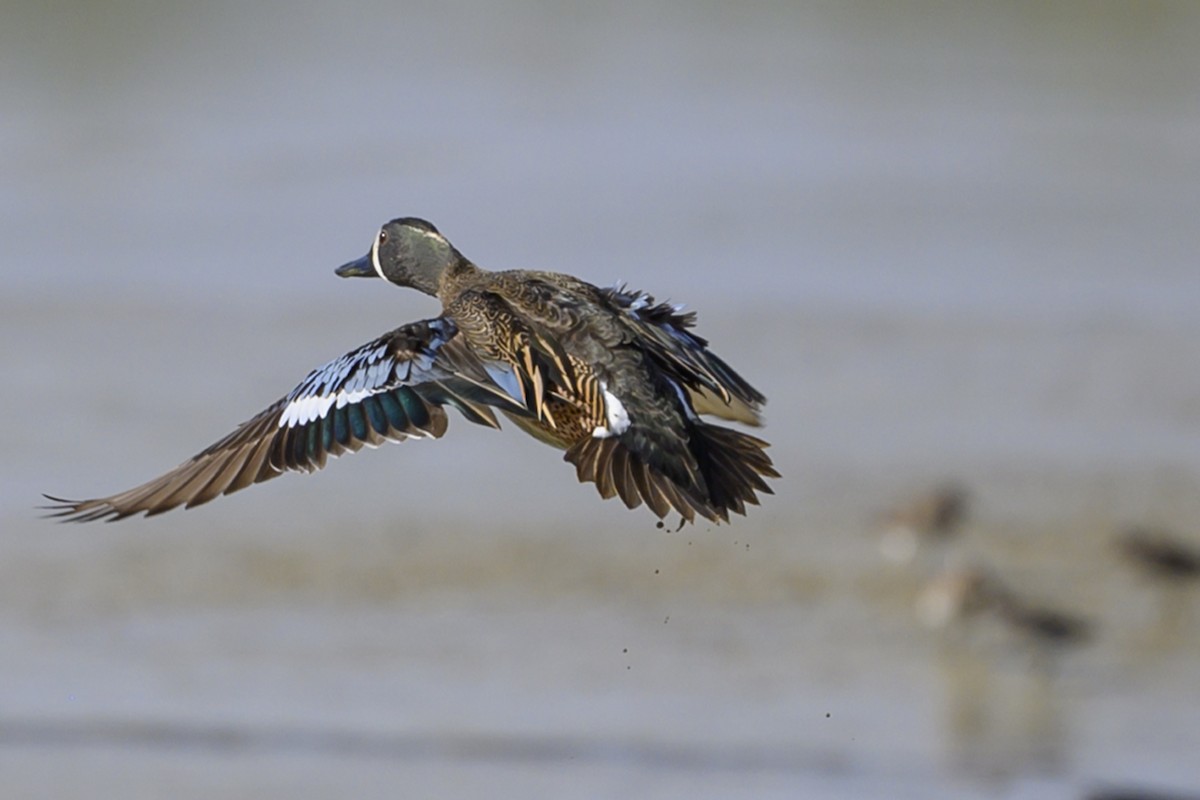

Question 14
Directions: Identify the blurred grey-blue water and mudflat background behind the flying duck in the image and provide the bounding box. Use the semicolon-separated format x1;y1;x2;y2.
0;0;1200;799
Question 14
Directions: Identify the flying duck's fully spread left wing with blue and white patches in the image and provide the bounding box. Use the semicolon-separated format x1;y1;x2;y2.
47;318;527;522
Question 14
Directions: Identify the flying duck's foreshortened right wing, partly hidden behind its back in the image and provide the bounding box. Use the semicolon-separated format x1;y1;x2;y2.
601;285;767;426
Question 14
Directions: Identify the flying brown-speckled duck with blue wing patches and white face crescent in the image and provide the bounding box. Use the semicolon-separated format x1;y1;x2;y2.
44;217;780;525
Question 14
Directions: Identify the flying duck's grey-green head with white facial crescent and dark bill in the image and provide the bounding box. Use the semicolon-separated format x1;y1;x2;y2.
336;217;466;295
